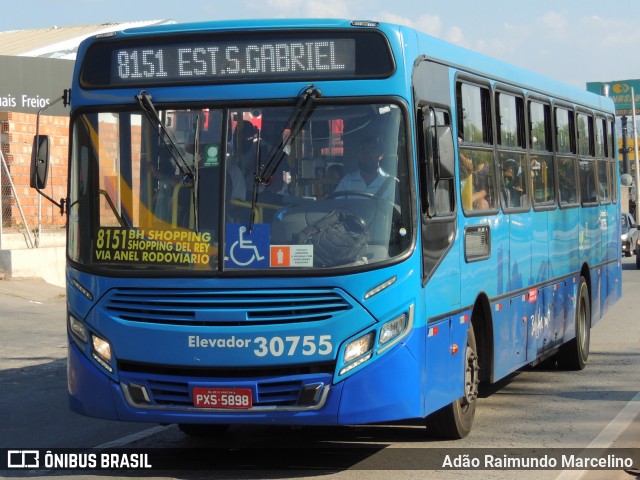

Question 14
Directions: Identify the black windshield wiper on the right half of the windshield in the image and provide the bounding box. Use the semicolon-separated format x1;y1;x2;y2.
249;85;322;231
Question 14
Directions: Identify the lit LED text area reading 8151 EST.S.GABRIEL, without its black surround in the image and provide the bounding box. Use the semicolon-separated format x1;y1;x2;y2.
112;39;356;83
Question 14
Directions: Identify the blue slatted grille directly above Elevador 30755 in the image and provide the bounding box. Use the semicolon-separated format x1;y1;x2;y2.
103;289;353;326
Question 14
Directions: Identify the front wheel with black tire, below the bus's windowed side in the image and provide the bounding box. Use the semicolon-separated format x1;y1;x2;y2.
426;325;480;440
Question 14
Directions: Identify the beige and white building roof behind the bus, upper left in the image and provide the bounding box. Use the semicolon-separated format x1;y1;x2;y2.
0;20;175;60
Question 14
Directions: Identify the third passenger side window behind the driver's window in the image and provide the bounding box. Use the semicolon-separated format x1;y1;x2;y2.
529;101;556;206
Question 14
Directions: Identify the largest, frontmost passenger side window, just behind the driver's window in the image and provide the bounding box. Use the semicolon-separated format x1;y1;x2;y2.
456;82;498;214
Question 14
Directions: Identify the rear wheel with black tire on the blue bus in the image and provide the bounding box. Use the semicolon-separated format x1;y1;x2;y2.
558;277;591;370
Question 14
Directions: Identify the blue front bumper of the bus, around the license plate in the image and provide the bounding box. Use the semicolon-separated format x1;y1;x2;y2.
68;342;424;425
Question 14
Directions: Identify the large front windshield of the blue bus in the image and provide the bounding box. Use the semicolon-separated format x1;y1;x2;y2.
68;97;413;272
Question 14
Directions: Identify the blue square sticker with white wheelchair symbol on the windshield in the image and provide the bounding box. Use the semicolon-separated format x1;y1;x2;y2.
224;223;270;268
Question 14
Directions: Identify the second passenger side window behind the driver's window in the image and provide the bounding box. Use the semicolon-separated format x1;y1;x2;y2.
496;92;531;210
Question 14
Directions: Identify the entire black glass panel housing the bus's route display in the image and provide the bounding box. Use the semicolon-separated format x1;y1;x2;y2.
80;31;395;88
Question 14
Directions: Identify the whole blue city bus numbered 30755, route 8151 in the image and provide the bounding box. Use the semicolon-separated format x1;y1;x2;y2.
34;19;621;438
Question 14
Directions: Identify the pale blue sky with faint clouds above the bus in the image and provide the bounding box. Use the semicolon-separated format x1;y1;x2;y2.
0;0;640;88
